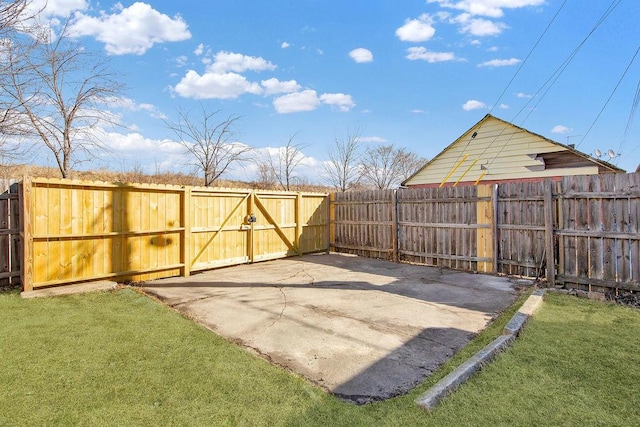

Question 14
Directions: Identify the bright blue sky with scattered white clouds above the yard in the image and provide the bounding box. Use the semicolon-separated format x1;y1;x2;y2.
21;0;640;183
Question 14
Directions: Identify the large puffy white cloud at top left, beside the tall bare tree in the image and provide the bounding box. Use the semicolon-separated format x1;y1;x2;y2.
70;2;191;55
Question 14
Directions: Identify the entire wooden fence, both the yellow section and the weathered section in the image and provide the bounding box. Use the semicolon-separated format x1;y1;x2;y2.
5;174;640;291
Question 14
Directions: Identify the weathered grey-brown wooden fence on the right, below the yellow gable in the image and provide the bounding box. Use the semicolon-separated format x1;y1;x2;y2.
330;174;640;291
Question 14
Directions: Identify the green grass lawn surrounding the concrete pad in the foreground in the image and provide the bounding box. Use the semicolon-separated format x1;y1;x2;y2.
0;289;640;426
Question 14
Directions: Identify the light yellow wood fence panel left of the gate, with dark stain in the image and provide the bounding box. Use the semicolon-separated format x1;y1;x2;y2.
23;179;184;288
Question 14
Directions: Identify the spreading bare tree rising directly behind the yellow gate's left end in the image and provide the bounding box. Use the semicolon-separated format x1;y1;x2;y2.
165;104;252;187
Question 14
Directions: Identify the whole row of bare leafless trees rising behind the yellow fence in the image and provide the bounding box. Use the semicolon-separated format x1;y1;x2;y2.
0;0;425;191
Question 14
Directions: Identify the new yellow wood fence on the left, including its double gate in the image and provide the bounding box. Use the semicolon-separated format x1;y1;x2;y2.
21;178;329;291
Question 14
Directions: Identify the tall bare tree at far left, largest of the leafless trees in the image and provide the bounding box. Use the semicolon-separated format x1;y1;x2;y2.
2;22;123;178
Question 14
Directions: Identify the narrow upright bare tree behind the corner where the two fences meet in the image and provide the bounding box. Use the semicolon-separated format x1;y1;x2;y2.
324;129;361;191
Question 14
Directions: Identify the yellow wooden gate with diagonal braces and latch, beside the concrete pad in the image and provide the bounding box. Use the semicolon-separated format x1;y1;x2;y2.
189;188;328;271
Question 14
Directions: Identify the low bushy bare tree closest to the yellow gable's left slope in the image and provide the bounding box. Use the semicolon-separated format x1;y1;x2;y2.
361;144;424;190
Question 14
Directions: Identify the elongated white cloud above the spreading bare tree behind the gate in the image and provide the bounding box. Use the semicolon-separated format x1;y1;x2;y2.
173;70;263;99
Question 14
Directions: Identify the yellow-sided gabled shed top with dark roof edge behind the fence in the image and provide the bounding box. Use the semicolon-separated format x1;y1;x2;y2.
402;114;624;187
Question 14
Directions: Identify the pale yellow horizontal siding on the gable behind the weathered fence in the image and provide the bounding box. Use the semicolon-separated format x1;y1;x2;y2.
405;116;598;185
